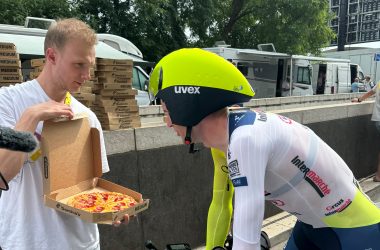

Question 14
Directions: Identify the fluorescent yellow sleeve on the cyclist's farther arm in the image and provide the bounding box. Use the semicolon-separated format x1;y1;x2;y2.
206;148;234;250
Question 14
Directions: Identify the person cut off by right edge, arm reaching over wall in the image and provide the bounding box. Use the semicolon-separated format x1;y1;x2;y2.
352;82;380;182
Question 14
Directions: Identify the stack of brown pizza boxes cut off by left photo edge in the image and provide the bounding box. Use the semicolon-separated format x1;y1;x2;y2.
0;42;23;87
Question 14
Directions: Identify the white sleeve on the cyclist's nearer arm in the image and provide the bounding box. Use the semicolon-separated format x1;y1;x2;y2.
228;126;270;250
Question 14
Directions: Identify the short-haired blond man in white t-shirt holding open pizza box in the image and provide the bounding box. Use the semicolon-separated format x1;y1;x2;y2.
0;19;128;250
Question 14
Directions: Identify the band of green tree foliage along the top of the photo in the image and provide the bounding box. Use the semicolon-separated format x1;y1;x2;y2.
0;0;334;61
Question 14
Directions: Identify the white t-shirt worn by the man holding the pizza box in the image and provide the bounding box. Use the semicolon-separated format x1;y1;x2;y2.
0;80;109;250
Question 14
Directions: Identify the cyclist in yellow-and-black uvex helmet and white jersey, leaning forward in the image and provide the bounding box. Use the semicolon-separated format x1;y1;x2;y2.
149;49;380;250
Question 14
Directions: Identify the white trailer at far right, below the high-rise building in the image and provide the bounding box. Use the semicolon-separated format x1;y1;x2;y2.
322;42;380;83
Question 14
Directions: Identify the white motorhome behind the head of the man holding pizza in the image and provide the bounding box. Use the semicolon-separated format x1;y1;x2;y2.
0;17;151;106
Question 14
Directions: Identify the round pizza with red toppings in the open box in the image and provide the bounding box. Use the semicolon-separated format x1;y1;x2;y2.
67;192;137;213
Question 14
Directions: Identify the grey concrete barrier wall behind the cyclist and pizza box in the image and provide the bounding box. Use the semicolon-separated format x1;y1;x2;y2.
99;97;380;250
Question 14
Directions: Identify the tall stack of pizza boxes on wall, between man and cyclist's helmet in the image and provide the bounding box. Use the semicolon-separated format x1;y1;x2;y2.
91;58;141;130
